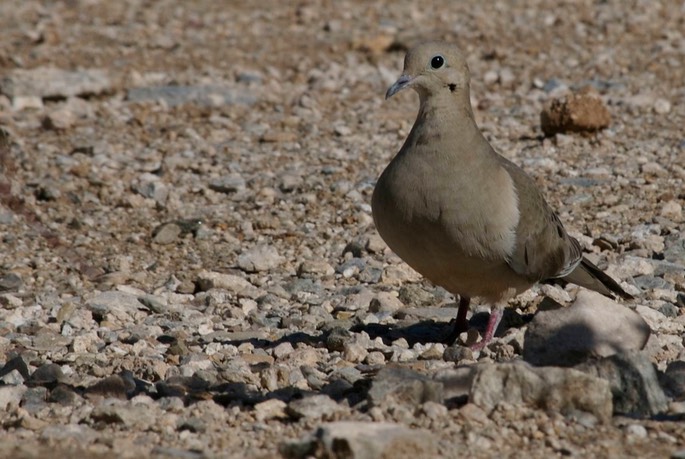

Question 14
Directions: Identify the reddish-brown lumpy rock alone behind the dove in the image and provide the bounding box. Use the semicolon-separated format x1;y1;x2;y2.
540;93;611;136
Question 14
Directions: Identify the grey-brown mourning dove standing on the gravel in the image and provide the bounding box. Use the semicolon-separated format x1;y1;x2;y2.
372;42;632;349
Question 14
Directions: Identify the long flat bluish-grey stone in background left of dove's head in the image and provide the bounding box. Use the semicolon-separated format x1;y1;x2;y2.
127;85;257;107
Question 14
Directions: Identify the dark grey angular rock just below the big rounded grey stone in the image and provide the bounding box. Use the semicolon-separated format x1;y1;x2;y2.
575;351;667;417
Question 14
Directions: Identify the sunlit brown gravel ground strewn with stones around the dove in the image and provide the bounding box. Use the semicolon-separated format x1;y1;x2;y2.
0;0;685;458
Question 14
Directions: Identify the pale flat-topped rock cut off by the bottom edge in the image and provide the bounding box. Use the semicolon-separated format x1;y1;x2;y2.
279;421;438;459
